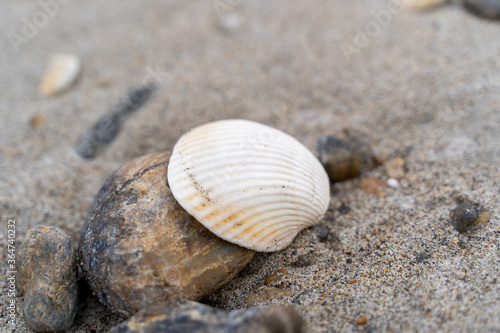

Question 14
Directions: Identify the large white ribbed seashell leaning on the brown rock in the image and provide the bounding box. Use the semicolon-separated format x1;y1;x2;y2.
168;120;330;252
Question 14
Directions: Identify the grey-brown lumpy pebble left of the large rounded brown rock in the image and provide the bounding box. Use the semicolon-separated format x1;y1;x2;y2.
17;226;78;332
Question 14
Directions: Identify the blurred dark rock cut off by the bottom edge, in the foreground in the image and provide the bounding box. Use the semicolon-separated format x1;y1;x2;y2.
109;301;302;333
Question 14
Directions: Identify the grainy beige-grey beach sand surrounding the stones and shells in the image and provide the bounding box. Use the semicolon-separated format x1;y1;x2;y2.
0;0;500;333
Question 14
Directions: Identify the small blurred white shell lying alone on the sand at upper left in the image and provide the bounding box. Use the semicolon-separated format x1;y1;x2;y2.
39;54;82;96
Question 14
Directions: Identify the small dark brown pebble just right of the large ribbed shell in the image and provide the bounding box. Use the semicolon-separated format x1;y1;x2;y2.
316;136;361;182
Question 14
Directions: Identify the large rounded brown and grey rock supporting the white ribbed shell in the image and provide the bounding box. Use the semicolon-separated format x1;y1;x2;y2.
79;153;255;317
